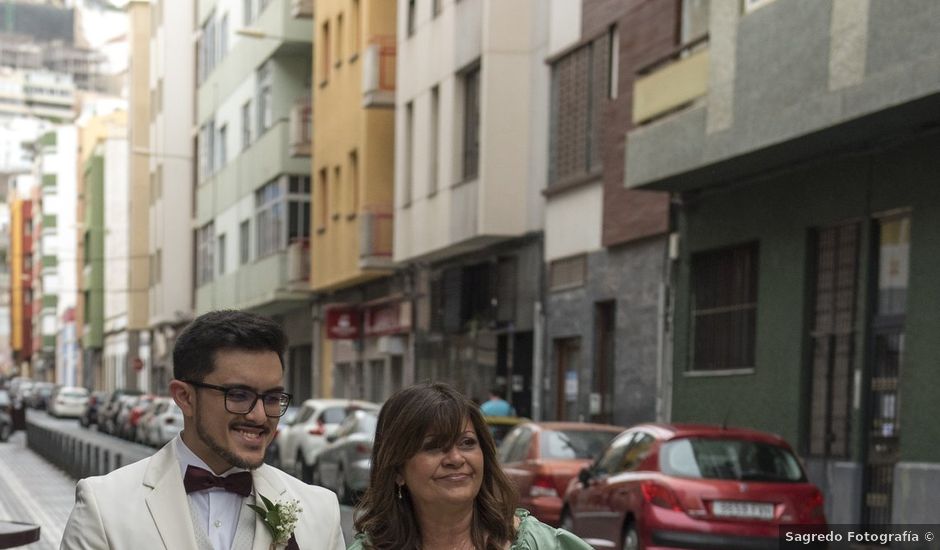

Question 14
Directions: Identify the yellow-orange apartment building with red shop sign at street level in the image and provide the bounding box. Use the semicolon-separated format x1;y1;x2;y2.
311;0;396;401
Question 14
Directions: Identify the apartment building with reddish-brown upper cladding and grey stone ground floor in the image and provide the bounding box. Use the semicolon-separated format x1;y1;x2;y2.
544;0;681;425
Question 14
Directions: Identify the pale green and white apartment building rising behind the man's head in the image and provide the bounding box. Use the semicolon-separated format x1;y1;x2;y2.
193;0;313;399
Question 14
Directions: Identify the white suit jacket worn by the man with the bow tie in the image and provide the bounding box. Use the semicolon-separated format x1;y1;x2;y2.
60;441;346;550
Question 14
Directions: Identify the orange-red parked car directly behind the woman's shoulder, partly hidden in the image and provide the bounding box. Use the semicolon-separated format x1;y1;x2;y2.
499;422;623;526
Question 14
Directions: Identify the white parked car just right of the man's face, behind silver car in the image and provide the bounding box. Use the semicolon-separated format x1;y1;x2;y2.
277;399;380;483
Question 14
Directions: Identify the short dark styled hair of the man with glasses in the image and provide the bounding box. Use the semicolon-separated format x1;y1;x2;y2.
173;309;287;382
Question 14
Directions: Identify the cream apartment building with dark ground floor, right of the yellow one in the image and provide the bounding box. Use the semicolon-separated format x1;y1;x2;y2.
394;0;549;417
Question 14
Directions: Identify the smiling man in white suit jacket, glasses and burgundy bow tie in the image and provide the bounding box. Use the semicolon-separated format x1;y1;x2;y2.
61;311;345;550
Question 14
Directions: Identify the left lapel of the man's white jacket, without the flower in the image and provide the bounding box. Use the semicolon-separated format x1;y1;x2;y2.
143;440;197;550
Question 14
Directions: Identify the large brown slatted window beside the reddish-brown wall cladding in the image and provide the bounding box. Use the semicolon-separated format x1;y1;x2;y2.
548;31;616;185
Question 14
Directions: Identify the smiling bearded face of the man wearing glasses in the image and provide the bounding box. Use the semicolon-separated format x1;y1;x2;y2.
170;350;284;474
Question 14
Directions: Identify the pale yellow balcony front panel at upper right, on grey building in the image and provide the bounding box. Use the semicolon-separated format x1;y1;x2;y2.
633;34;708;124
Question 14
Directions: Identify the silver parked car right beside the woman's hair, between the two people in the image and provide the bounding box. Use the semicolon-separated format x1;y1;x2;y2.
313;410;378;504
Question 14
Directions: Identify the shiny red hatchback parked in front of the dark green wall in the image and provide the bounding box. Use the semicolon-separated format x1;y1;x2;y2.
562;424;826;550
